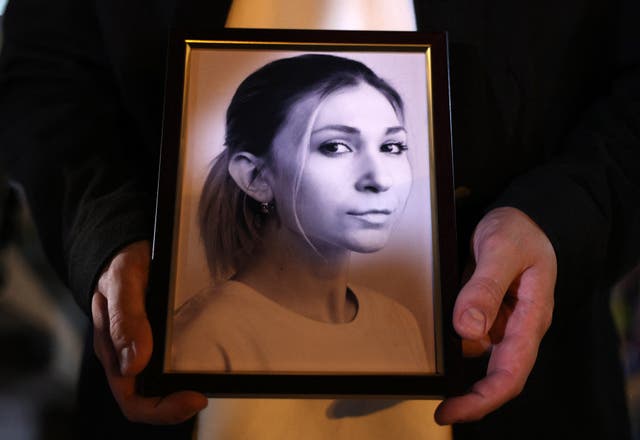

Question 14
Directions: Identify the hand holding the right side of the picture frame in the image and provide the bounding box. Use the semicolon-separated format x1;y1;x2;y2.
435;208;557;424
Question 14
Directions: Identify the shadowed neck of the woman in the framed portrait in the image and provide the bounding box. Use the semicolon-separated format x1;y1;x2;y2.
234;226;357;323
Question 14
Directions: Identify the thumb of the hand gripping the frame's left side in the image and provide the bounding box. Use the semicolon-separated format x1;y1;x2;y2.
98;242;153;375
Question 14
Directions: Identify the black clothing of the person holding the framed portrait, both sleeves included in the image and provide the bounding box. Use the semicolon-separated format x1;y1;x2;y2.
0;0;640;439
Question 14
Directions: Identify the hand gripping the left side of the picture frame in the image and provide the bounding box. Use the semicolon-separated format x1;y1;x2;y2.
91;241;207;424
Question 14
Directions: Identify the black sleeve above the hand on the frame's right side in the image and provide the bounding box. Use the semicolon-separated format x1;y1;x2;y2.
494;0;640;306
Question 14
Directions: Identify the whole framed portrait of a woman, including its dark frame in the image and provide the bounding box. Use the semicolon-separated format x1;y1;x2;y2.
140;29;460;398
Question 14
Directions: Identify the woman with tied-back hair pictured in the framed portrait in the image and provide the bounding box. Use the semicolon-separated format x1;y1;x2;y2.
172;55;435;373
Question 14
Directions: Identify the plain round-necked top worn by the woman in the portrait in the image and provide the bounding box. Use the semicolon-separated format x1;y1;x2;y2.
170;281;435;373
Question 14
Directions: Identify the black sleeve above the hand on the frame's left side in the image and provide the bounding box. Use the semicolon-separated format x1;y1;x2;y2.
0;0;155;316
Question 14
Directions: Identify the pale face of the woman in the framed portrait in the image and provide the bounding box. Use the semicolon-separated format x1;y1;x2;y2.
272;83;412;253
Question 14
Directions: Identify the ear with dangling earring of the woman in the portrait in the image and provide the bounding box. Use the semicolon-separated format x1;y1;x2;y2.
229;151;273;203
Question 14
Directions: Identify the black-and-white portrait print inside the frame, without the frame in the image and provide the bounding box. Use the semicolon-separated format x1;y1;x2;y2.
165;48;436;374
